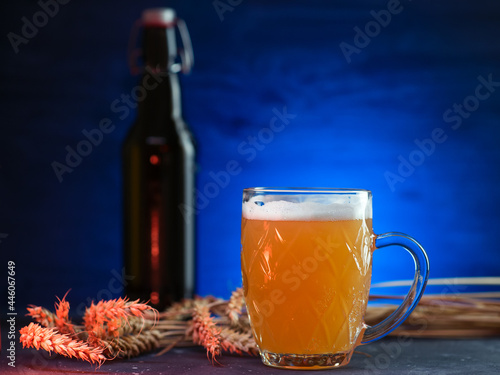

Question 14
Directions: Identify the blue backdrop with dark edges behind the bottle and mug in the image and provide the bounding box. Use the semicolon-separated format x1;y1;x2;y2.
0;0;500;311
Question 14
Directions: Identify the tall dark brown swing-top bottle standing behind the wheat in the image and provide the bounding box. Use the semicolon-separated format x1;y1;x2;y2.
123;8;195;309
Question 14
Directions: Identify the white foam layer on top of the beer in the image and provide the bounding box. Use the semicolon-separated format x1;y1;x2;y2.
243;196;372;221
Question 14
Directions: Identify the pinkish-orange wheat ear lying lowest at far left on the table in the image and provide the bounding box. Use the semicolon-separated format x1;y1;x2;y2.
19;323;106;366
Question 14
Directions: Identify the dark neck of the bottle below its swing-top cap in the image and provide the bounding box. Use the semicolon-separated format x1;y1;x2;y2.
138;27;182;132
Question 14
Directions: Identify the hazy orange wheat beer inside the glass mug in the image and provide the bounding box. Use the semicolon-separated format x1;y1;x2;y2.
241;203;372;354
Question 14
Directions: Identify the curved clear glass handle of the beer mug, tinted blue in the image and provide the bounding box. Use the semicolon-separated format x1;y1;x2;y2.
361;232;429;345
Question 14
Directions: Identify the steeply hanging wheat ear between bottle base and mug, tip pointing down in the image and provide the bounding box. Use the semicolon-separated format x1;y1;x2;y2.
187;301;221;362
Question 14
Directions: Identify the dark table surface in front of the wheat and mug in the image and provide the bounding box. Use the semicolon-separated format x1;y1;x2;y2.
0;337;500;375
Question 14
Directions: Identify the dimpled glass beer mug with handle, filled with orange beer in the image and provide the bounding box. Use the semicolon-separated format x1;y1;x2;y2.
241;188;429;369
